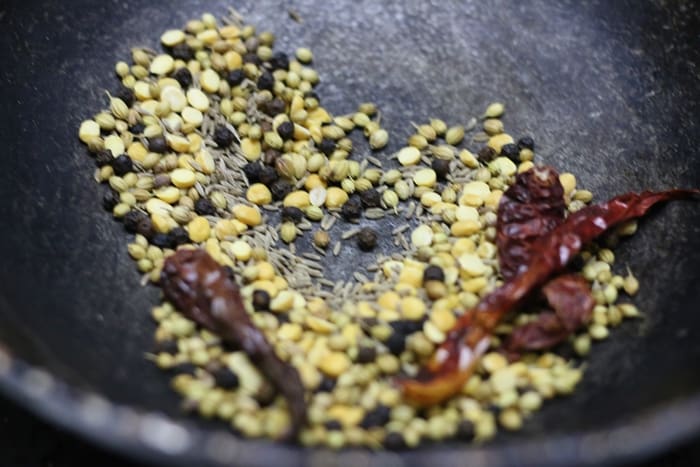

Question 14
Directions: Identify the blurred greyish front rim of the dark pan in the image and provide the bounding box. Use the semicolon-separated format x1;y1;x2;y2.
0;341;700;467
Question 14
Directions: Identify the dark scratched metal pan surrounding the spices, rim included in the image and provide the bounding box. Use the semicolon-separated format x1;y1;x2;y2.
0;0;700;466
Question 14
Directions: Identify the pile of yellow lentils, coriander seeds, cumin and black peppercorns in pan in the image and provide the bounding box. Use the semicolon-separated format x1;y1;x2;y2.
74;12;696;449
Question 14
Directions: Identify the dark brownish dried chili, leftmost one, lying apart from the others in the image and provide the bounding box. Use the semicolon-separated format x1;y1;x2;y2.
161;250;306;439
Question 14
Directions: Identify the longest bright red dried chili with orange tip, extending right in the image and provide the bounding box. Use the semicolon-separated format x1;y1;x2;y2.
397;186;700;405
